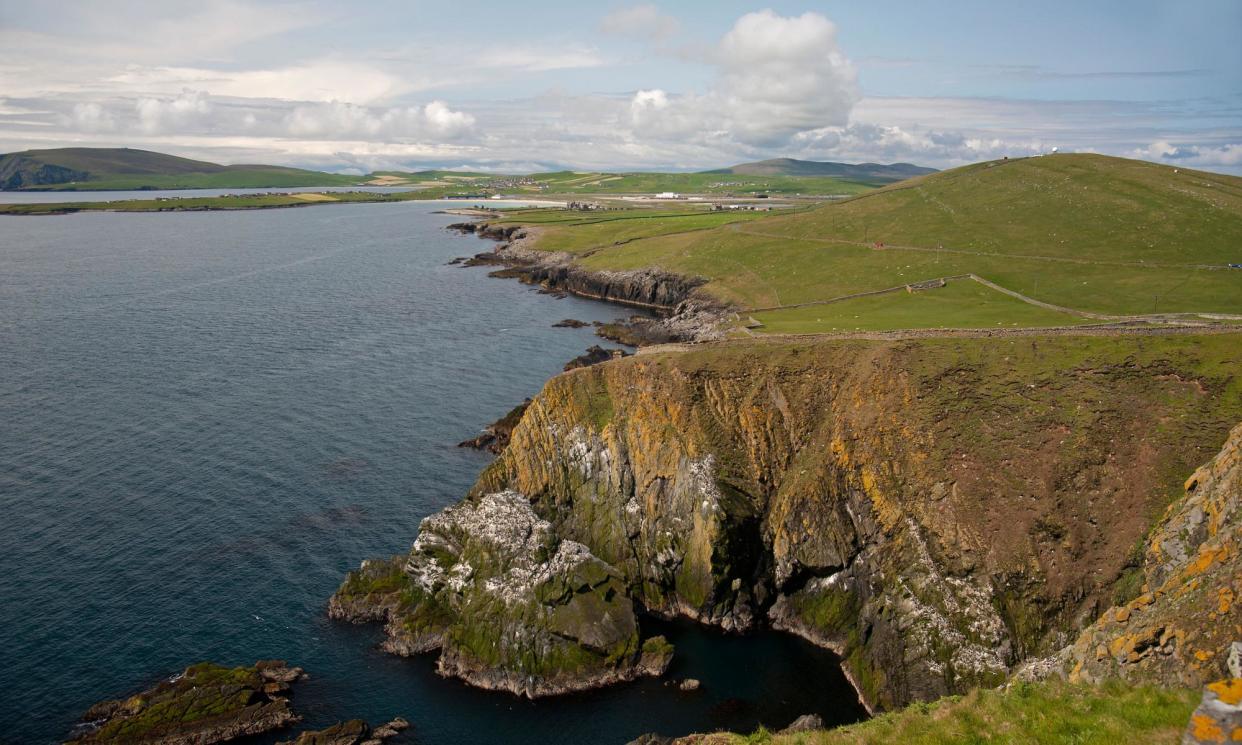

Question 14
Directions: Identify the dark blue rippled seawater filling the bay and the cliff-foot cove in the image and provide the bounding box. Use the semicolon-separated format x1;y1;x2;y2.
0;204;862;744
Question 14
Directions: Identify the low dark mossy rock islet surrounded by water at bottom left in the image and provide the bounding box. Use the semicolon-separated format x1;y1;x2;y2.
70;661;303;745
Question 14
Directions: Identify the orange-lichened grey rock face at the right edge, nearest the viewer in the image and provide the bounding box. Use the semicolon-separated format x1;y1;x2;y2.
1063;425;1242;687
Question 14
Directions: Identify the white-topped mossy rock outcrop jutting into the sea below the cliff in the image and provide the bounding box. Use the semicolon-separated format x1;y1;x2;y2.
328;490;672;698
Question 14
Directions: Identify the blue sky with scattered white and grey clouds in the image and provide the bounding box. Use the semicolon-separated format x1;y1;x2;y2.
0;0;1242;174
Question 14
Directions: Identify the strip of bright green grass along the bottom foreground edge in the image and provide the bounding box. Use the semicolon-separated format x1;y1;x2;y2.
674;682;1199;745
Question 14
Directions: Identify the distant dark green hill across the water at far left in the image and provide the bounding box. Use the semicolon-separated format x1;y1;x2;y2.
0;148;359;190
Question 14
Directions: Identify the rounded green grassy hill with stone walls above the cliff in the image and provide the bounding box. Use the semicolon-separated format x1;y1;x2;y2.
496;154;1242;333
